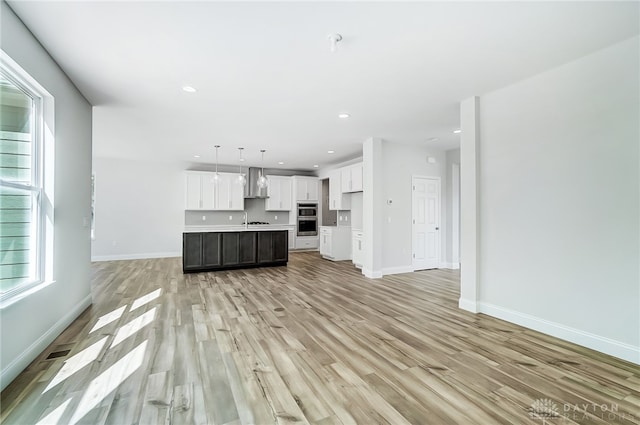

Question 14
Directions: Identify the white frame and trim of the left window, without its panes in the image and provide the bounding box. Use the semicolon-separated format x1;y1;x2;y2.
0;49;53;309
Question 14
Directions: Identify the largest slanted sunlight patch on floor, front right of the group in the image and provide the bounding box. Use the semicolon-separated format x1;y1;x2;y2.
70;340;148;425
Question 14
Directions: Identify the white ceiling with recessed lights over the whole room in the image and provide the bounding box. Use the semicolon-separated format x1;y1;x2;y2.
9;0;639;170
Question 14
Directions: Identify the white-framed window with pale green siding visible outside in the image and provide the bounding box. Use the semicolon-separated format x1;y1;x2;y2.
0;52;51;302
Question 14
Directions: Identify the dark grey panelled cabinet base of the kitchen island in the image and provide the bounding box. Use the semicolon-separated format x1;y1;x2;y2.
182;230;289;273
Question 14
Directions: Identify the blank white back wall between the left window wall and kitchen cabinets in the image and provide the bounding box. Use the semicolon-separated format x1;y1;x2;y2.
92;158;185;260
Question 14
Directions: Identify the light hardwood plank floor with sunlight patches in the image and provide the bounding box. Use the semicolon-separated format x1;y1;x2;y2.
0;252;640;425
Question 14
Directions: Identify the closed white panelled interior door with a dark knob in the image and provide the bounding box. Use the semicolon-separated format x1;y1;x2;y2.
412;177;440;270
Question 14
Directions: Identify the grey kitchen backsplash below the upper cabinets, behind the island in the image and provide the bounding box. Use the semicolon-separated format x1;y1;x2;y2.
184;199;289;226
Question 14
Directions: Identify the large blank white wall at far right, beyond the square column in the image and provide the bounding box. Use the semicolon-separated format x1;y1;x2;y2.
462;37;640;363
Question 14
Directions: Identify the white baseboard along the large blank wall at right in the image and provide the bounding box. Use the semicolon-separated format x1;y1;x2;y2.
478;299;640;365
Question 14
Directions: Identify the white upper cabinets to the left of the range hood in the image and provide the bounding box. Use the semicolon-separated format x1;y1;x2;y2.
185;171;244;211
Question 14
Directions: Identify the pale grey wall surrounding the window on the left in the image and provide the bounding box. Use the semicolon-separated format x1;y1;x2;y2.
0;2;91;388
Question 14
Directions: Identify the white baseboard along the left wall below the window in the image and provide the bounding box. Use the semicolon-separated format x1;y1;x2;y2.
0;294;91;390
